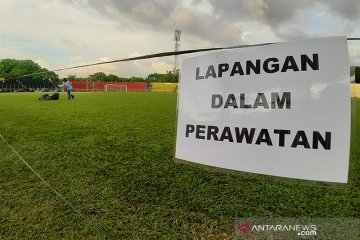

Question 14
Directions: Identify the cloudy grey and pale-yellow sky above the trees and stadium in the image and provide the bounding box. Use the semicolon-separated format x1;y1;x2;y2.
0;0;360;76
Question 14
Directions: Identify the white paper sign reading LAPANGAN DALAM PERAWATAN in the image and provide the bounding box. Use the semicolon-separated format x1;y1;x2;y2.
175;37;350;183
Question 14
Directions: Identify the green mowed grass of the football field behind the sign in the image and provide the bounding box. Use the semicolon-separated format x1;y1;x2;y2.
0;93;360;239
